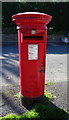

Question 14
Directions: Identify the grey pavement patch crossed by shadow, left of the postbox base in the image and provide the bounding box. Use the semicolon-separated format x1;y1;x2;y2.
0;85;27;117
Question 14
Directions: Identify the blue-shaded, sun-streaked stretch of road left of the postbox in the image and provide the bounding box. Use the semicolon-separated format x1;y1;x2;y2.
2;45;19;85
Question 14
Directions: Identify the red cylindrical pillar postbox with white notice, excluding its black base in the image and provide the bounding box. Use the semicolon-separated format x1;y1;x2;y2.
12;12;52;98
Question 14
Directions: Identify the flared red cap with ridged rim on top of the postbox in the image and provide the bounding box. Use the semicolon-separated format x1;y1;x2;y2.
12;12;52;26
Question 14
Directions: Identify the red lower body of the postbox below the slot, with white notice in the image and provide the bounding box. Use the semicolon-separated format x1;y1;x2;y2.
20;43;45;98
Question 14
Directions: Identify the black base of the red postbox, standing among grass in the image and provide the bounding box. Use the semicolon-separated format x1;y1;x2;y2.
21;95;44;109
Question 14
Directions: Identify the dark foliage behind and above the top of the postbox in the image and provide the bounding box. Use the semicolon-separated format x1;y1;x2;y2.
2;2;69;32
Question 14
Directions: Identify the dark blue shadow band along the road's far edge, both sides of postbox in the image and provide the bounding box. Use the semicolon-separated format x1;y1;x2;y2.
2;43;69;54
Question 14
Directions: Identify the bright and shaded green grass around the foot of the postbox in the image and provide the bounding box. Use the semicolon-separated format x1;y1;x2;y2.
0;92;69;120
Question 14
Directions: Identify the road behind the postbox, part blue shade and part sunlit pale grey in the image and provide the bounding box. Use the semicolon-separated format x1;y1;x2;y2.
0;45;69;86
